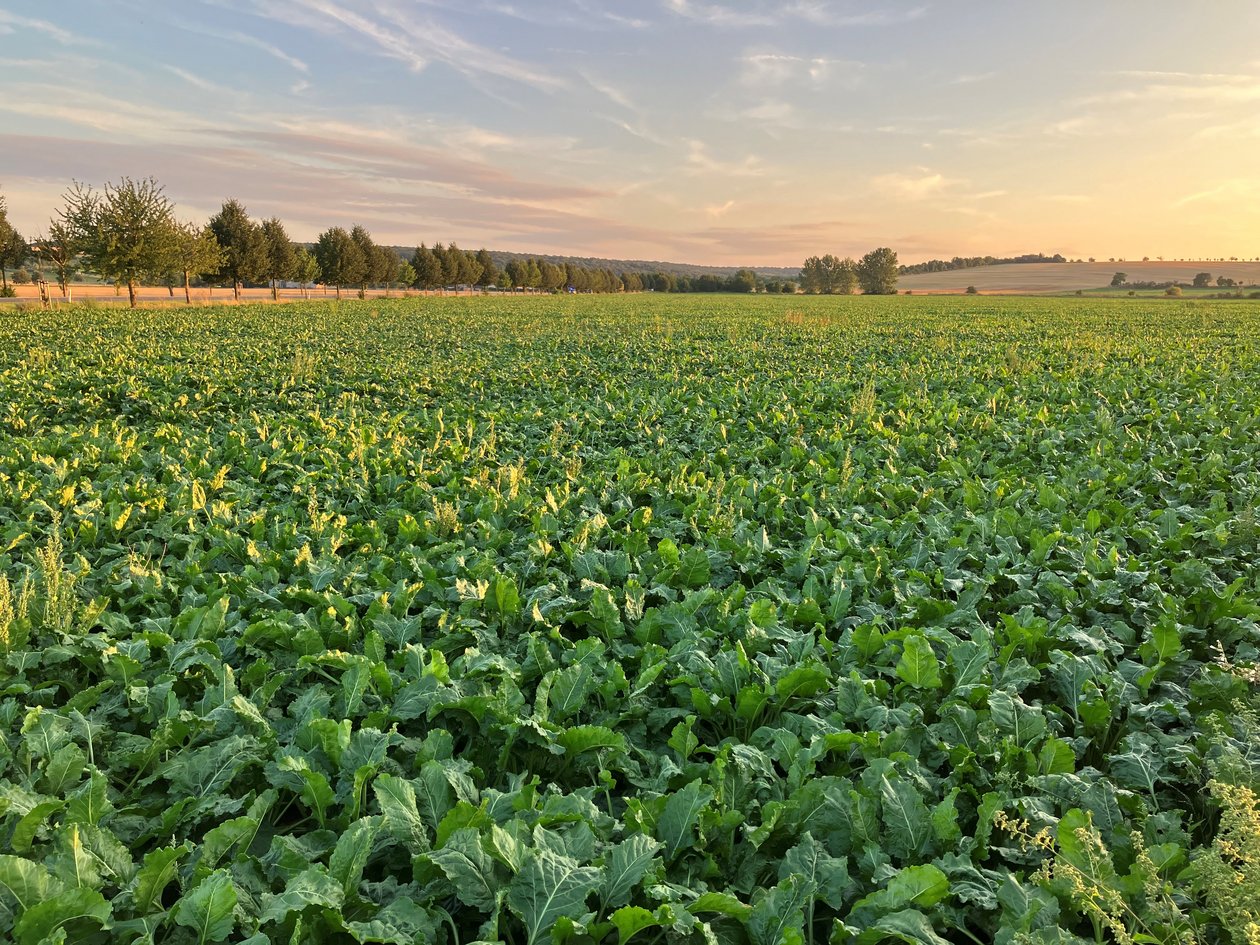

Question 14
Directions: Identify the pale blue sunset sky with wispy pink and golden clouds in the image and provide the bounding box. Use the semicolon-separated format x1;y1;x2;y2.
0;0;1260;266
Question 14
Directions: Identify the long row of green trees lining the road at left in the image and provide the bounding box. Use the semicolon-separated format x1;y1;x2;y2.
0;178;796;307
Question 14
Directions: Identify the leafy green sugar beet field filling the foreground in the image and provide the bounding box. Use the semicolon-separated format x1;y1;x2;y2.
0;296;1260;945
